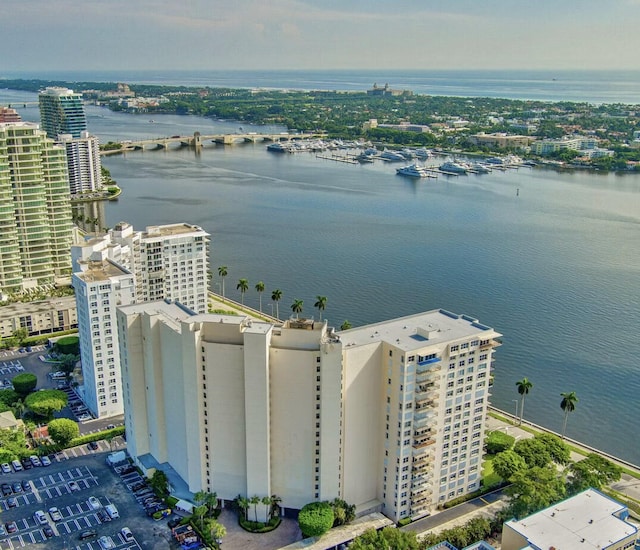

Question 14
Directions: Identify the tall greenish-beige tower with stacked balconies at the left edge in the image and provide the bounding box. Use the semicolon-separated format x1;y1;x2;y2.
0;122;73;293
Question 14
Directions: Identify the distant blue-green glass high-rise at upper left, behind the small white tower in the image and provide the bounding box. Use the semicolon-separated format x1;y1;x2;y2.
38;87;87;140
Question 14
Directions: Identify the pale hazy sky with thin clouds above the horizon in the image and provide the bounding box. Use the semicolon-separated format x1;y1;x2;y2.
0;0;640;76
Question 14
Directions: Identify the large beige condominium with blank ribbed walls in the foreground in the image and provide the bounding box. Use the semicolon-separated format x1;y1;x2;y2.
117;301;500;520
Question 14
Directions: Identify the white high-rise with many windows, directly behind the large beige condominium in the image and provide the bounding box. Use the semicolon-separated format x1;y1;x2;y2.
71;222;209;417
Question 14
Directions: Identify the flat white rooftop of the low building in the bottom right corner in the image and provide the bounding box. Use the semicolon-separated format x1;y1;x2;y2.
505;489;637;550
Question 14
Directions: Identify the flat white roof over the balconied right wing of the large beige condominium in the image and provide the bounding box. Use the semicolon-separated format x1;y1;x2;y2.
339;309;501;351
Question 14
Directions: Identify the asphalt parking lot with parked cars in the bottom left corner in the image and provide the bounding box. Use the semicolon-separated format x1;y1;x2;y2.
0;450;171;550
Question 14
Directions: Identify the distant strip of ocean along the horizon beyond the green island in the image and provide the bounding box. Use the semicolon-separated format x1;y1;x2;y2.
0;69;640;104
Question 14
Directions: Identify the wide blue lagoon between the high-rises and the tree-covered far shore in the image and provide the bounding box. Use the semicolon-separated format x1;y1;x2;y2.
0;75;640;464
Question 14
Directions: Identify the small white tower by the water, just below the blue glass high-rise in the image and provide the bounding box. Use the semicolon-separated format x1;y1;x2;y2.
58;131;102;195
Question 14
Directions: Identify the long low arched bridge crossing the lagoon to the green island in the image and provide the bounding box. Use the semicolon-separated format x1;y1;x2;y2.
101;132;325;155
